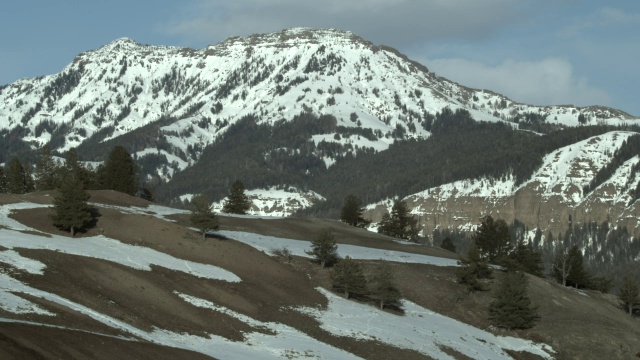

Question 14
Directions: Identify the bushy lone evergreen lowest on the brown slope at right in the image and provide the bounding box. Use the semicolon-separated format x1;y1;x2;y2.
489;271;540;330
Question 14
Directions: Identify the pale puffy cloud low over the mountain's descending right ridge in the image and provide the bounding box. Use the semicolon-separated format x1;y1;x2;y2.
425;58;611;106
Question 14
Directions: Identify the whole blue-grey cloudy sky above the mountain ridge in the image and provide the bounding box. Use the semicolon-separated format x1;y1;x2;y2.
0;0;640;116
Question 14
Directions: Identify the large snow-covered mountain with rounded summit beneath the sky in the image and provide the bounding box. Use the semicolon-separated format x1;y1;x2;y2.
0;29;633;170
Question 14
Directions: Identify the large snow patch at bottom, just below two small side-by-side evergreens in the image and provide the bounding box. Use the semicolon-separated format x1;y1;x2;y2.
298;288;553;360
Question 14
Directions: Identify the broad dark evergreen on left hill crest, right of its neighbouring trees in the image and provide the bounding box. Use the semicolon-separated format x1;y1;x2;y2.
100;145;138;195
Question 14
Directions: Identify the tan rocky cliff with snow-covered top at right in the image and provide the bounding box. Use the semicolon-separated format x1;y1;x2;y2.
366;131;640;242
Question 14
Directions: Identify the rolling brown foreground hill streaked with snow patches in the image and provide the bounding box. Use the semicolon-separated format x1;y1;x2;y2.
0;191;640;359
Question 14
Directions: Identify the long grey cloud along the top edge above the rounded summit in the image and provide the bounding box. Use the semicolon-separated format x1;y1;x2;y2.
159;0;519;47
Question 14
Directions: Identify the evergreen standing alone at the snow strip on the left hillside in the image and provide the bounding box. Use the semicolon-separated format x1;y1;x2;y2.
50;176;94;237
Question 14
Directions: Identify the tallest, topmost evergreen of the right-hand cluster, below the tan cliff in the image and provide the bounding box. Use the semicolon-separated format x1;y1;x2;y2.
473;215;511;264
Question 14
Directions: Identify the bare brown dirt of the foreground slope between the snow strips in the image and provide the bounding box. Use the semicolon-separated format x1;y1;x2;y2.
0;191;640;359
